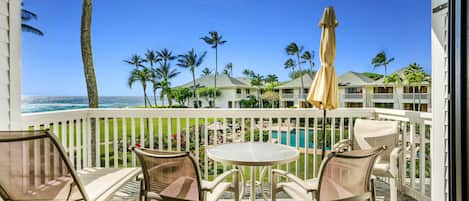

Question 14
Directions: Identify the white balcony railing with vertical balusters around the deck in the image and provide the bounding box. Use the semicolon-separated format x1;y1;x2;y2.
22;108;432;200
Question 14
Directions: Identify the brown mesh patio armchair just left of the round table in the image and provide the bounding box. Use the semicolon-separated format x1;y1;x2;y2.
130;147;239;201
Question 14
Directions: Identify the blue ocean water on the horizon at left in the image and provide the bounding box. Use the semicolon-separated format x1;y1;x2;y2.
21;96;144;113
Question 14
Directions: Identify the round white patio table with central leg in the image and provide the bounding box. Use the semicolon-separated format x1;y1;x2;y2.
207;142;300;200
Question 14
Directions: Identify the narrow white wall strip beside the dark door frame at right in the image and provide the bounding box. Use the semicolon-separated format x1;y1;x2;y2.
430;0;448;201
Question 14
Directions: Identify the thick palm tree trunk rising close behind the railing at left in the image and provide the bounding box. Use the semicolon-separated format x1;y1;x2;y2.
80;0;99;166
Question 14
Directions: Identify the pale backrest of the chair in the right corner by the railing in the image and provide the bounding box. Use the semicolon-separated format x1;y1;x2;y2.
352;119;399;163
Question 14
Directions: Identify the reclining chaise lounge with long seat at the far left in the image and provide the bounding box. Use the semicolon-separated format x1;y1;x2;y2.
0;131;139;201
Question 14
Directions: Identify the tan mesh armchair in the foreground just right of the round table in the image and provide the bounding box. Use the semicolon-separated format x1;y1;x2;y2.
271;147;386;201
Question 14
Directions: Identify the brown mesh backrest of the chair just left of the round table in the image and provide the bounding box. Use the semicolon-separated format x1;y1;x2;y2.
130;147;203;200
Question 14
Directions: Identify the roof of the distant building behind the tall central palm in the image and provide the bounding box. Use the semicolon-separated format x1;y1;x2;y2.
178;74;251;88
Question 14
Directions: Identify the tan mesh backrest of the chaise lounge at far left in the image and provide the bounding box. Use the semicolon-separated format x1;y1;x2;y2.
0;131;89;201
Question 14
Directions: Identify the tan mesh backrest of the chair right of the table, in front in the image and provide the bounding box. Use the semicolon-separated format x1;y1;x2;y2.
316;146;386;201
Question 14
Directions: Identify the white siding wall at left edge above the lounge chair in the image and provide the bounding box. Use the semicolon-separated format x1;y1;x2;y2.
0;0;21;130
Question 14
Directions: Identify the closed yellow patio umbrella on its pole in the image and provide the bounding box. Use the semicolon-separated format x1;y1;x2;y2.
308;7;339;158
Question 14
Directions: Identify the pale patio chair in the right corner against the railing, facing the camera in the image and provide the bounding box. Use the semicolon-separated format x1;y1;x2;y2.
334;119;402;201
